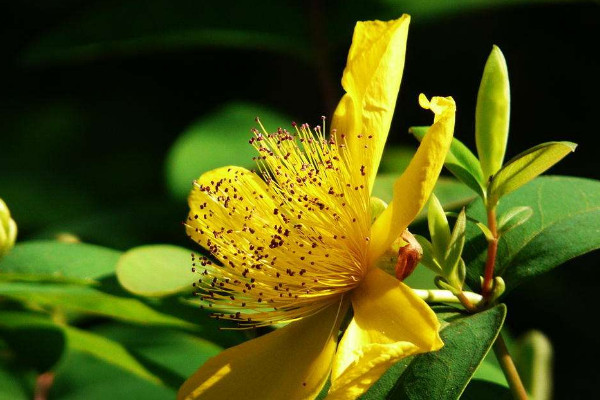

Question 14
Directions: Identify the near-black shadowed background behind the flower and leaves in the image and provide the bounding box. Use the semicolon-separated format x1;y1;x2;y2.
0;0;600;398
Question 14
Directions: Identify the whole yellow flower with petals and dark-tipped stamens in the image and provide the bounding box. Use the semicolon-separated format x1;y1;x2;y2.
178;15;455;399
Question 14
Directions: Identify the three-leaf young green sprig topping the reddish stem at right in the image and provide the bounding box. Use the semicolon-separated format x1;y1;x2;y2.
410;46;577;208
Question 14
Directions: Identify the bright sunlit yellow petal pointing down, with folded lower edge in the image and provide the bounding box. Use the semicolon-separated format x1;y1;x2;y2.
327;268;443;400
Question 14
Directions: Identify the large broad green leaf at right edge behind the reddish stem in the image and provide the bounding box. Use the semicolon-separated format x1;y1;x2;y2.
463;176;600;293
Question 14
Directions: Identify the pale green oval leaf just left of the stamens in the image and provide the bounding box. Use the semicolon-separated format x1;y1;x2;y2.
117;245;198;297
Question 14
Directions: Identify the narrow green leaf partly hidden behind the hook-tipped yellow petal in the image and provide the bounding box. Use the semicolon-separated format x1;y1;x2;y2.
408;126;486;196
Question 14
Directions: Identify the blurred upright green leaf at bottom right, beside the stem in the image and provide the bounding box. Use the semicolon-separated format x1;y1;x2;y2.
514;331;553;400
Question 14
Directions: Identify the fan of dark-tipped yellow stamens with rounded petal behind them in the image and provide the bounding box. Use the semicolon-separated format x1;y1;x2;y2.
185;118;371;328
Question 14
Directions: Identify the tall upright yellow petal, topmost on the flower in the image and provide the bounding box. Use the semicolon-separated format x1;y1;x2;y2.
332;15;410;192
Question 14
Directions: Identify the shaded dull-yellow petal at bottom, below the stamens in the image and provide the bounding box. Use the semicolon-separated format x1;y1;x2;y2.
177;301;346;400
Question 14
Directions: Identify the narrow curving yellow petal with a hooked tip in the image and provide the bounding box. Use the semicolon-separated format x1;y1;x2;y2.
369;95;456;265
